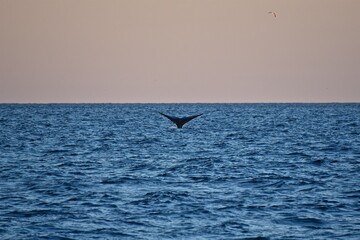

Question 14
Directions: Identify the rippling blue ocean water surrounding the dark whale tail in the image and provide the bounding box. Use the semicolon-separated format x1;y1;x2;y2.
0;104;360;239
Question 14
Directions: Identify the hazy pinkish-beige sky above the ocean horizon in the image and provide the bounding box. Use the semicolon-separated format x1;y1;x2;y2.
0;0;360;103
